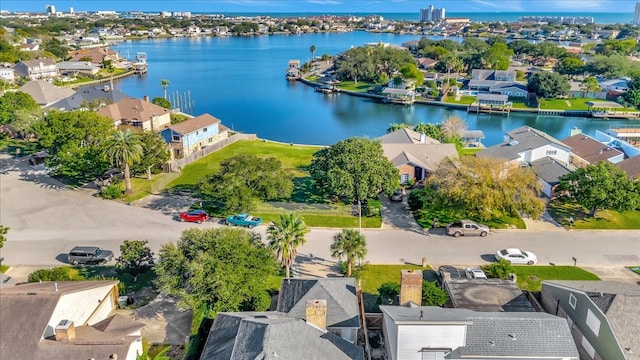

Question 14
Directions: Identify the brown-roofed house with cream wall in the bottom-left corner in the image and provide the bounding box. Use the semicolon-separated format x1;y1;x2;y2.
0;280;144;360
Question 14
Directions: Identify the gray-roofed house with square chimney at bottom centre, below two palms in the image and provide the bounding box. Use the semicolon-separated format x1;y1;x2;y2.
200;278;364;360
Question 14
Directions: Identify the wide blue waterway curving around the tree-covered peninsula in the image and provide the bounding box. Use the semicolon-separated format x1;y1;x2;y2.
113;31;640;145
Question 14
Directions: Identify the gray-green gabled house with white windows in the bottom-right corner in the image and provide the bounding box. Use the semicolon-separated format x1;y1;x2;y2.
542;280;640;360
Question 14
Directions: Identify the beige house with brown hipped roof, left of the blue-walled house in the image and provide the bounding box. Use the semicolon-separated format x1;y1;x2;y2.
98;96;171;131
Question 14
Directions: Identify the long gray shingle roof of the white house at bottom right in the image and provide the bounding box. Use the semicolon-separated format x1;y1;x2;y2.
380;306;578;359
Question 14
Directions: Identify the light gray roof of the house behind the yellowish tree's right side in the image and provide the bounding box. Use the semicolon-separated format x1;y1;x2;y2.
476;126;571;160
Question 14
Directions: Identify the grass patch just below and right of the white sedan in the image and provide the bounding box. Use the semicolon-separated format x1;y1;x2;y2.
513;265;600;291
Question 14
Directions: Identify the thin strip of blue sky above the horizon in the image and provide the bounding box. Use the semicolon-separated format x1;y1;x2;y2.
0;0;635;14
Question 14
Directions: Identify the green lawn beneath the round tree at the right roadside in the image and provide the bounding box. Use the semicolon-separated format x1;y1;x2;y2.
548;201;640;230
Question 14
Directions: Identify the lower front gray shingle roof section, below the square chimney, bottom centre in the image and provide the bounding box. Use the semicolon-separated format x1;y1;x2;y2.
205;312;364;360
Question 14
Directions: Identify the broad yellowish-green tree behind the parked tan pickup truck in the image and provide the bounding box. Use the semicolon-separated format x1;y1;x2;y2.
422;156;544;221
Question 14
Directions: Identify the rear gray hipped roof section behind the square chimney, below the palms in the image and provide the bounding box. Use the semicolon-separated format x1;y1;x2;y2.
276;278;360;328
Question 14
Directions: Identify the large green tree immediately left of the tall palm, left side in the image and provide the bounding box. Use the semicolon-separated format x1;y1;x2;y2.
33;110;114;181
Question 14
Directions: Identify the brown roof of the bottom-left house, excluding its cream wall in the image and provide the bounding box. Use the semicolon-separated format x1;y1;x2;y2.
0;280;144;360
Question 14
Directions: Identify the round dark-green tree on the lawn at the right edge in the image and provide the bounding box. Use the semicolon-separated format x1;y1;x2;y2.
557;161;640;217
